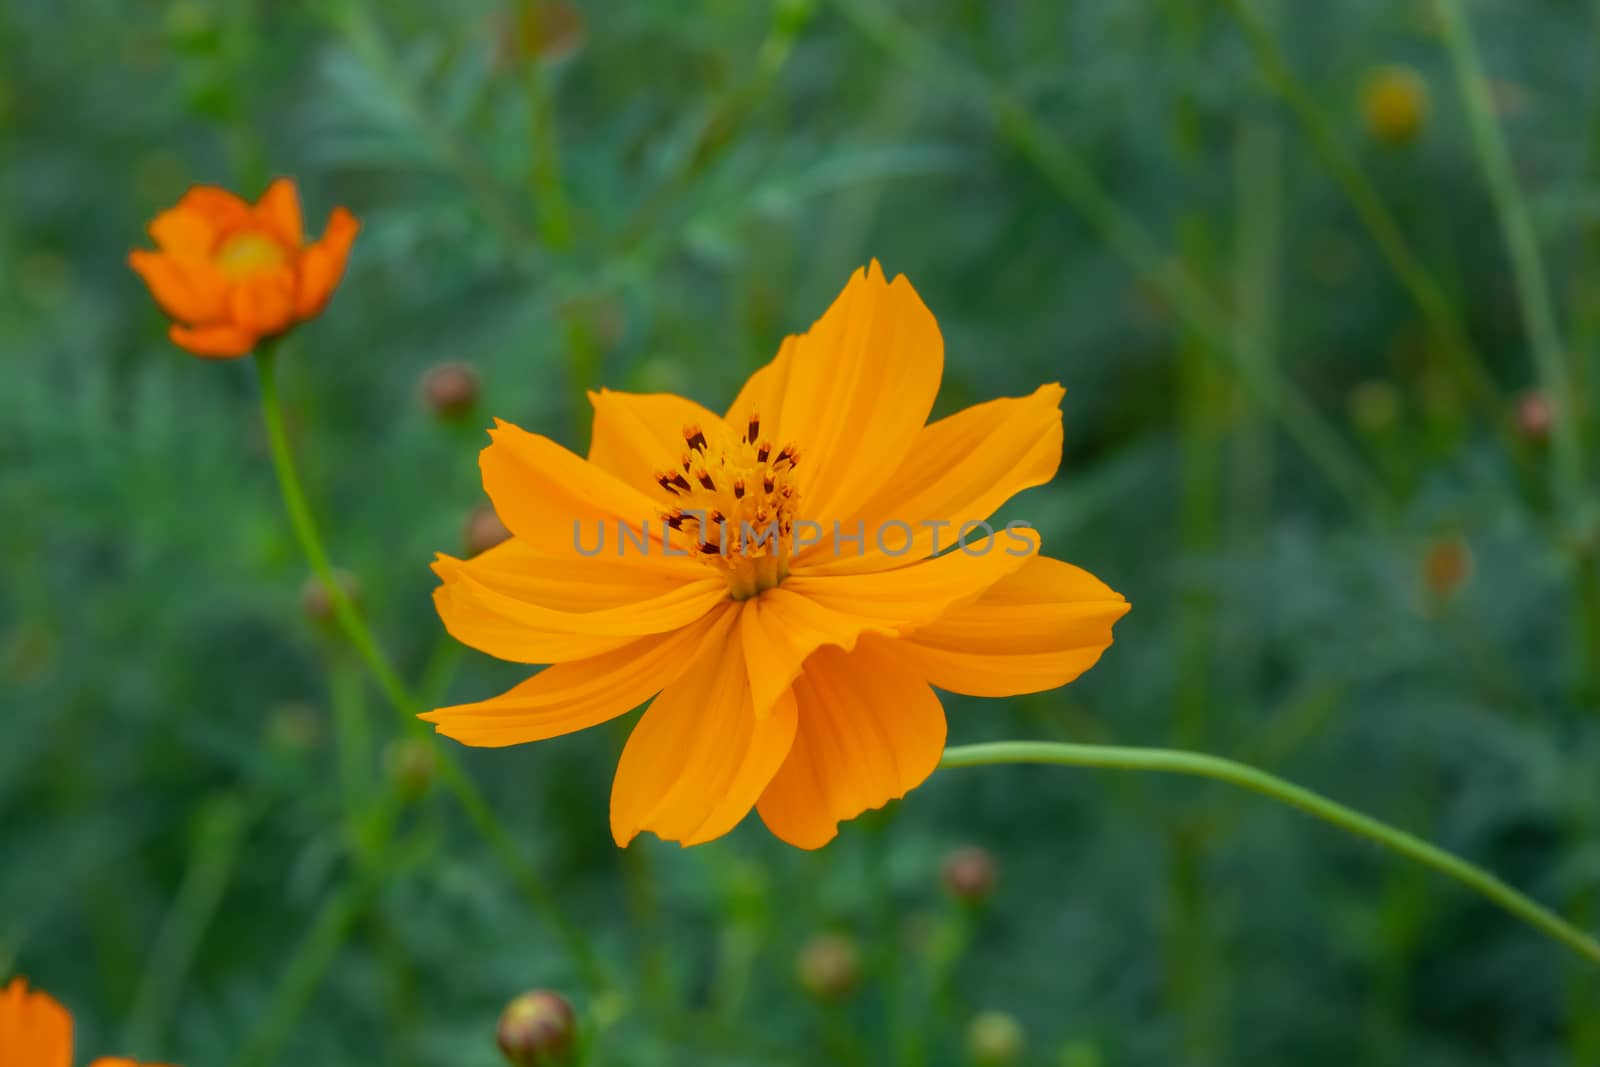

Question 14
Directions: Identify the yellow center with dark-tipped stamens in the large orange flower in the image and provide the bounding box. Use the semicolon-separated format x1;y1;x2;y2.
656;413;800;600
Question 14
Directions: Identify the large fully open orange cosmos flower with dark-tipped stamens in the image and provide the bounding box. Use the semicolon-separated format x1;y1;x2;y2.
424;261;1128;848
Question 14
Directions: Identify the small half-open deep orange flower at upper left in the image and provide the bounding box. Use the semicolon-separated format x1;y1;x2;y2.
128;178;360;360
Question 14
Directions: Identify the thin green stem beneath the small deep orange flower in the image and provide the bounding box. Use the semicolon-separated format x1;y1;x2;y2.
256;342;608;989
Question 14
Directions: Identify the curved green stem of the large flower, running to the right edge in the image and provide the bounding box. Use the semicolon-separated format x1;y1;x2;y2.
939;741;1600;965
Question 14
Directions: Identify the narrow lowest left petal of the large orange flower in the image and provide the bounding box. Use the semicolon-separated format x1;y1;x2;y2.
421;613;726;747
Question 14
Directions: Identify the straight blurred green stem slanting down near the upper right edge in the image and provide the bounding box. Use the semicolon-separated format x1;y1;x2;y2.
1438;0;1587;518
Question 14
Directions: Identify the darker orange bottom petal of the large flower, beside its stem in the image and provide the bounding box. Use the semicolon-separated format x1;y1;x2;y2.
758;637;946;848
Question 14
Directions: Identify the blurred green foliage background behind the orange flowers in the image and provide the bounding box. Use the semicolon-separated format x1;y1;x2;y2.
0;0;1600;1067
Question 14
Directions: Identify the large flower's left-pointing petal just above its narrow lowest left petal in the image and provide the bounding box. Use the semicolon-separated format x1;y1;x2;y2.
434;542;728;664
